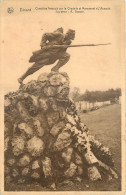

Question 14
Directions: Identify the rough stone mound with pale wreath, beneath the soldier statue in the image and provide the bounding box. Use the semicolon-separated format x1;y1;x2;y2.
5;72;118;189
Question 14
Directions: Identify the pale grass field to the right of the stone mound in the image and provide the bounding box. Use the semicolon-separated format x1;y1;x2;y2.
78;104;121;190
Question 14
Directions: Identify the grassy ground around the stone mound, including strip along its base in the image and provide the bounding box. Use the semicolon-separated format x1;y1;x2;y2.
5;104;121;191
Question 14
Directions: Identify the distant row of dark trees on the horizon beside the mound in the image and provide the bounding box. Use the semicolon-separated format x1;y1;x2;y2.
71;87;121;102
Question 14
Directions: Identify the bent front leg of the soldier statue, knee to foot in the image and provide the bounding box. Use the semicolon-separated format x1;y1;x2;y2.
51;53;70;72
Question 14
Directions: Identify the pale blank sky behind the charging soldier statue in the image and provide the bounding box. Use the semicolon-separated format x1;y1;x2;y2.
1;2;122;93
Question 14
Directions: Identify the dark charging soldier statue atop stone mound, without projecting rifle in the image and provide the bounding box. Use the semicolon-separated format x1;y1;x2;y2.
18;27;75;84
